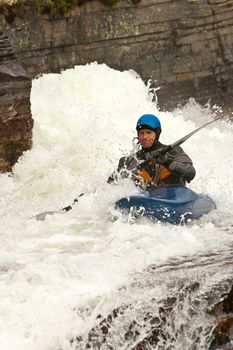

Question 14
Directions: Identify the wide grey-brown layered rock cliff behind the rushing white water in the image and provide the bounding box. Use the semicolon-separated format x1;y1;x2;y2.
0;0;233;108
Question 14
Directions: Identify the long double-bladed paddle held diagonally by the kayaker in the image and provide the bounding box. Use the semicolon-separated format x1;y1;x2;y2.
33;117;224;221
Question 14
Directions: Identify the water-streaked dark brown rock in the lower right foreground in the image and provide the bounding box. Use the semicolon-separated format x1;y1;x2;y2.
72;256;233;350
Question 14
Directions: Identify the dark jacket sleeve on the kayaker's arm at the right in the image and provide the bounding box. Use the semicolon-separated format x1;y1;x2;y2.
168;146;196;182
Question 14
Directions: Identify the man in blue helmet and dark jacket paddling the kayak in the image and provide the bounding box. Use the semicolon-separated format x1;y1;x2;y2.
108;114;196;188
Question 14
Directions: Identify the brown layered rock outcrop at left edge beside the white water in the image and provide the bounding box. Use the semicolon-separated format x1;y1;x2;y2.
0;32;33;172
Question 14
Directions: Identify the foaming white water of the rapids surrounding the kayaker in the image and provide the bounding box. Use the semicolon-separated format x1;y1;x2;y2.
0;63;233;350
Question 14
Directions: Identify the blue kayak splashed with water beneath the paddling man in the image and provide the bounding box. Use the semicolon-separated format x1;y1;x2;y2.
115;186;216;225
